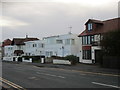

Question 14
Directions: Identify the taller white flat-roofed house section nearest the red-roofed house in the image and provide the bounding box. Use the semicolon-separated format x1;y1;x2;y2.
43;33;80;57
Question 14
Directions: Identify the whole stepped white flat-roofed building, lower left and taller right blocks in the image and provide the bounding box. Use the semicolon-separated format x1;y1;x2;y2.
24;34;80;57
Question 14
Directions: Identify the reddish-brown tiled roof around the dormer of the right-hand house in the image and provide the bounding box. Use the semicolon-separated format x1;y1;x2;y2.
78;18;120;37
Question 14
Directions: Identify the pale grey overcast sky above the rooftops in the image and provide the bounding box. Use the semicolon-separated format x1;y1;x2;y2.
0;0;119;40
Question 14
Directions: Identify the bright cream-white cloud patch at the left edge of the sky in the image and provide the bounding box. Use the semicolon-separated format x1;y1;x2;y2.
0;16;29;28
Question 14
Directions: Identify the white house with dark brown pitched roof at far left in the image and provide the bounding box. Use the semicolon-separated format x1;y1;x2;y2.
3;36;39;61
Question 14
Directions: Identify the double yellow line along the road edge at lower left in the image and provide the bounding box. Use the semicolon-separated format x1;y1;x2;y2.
0;77;26;90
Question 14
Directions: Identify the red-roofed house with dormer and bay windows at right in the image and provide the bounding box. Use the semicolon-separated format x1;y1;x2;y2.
78;18;120;63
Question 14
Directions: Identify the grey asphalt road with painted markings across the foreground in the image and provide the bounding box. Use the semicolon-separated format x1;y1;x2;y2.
2;62;119;88
